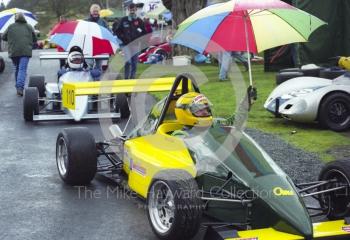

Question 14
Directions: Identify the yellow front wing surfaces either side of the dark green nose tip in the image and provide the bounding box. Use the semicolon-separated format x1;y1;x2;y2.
225;220;350;240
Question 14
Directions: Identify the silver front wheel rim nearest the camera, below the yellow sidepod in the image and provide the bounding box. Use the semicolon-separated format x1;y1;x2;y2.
148;181;175;234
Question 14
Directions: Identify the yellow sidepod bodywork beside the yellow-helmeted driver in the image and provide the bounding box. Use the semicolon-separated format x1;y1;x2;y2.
124;123;196;198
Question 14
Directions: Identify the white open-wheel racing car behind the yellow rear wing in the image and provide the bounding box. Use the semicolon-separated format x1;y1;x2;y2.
23;52;130;122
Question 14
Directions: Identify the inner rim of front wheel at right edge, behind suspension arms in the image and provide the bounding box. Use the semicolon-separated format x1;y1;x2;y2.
321;169;350;217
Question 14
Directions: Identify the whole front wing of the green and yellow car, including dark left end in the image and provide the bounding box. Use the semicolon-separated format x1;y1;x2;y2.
205;220;350;240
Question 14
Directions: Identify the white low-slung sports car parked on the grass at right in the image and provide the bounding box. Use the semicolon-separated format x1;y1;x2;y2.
264;72;350;131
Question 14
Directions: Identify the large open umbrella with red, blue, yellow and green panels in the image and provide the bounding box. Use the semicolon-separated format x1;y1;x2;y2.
172;0;326;85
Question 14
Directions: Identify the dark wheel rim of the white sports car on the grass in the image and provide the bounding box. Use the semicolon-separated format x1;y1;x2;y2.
328;100;350;124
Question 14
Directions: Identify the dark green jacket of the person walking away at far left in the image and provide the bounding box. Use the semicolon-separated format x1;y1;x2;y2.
2;13;37;57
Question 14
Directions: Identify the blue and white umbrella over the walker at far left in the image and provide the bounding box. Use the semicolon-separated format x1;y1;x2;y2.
0;8;38;33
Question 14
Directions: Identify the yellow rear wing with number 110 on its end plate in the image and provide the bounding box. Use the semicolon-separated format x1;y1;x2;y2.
62;77;181;110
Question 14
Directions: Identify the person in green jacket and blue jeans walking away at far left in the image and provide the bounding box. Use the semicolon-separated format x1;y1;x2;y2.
2;13;37;96
